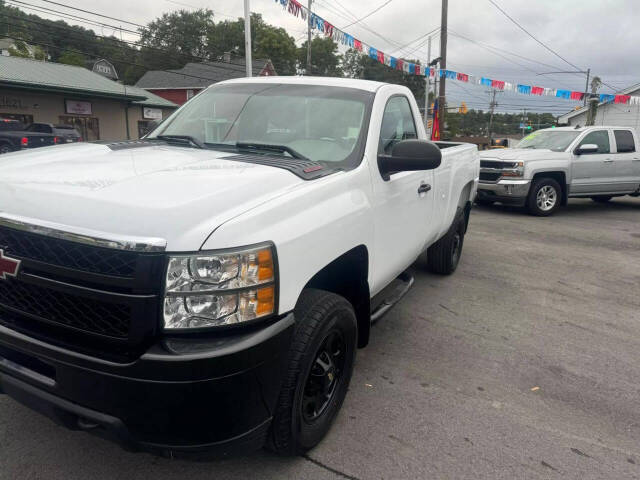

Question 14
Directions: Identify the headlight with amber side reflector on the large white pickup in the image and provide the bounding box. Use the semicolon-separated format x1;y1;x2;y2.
163;245;276;330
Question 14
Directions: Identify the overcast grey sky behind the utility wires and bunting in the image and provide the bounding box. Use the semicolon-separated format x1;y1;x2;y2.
8;0;640;114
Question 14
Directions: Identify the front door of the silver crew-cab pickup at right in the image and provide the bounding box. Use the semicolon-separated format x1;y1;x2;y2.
571;129;616;195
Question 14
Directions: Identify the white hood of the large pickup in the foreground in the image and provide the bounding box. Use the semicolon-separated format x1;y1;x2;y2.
0;143;304;251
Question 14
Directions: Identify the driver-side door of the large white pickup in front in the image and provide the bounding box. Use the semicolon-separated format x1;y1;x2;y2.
370;95;435;293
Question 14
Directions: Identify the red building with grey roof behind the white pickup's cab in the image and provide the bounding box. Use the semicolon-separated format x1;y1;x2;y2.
136;56;277;105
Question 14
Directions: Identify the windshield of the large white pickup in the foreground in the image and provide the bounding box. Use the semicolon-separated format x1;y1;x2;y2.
147;82;373;165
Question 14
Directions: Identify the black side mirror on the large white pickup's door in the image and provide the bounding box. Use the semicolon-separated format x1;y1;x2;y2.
378;140;442;180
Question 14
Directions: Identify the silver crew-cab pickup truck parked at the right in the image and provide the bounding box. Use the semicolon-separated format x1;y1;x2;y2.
477;126;640;216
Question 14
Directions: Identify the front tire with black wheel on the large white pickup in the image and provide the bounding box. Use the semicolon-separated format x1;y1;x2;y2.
267;289;358;456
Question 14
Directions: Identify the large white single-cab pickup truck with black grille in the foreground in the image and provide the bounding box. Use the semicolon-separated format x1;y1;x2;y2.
0;77;479;454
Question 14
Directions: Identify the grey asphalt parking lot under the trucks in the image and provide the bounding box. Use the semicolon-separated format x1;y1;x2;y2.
0;197;640;480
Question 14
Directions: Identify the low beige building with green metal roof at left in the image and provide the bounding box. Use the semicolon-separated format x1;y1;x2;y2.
0;56;178;140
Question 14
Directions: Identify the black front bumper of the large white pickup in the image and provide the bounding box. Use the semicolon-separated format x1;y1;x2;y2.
0;313;294;455
